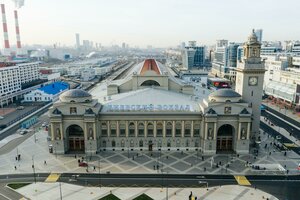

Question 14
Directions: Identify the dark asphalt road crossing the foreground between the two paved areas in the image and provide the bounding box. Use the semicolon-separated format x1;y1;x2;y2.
0;173;300;200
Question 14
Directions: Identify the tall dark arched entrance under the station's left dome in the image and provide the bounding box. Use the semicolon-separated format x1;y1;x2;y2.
66;124;85;152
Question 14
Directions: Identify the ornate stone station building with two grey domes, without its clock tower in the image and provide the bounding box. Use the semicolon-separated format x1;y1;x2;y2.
49;32;260;154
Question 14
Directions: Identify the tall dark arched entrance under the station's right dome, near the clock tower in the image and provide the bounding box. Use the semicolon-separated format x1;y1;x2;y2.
217;124;234;152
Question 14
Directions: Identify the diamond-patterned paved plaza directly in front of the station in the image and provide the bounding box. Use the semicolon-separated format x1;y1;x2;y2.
0;115;300;175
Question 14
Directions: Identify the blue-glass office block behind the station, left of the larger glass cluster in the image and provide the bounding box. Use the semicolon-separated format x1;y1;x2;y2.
182;41;205;69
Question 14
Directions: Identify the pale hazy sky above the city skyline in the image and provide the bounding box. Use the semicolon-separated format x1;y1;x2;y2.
1;0;300;47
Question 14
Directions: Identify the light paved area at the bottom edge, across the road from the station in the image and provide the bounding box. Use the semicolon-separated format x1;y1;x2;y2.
17;183;276;200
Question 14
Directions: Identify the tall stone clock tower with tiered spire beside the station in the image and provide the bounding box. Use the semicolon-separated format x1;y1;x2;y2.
235;30;266;142
